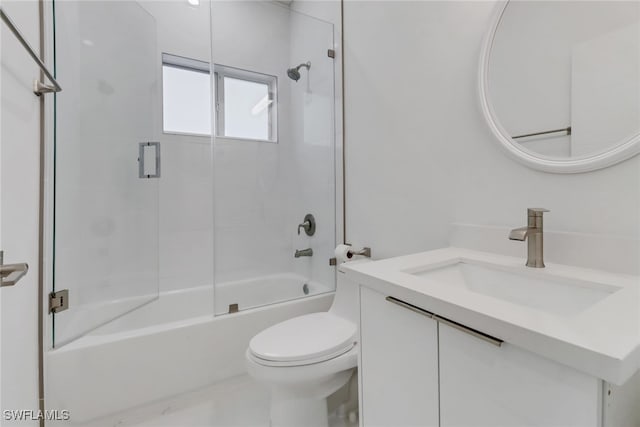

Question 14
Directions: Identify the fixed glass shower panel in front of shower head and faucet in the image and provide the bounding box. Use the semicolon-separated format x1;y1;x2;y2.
211;0;336;315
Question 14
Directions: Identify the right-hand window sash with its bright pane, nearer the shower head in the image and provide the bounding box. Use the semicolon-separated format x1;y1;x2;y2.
214;64;278;142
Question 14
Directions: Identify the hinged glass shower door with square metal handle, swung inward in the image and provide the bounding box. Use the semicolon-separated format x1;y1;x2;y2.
54;1;161;346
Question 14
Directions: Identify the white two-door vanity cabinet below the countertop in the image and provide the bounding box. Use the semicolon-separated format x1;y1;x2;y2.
359;287;640;427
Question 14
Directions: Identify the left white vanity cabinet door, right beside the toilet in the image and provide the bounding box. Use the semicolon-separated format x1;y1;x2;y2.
360;288;438;427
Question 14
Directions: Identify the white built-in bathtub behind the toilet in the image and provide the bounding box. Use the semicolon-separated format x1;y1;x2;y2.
45;273;333;425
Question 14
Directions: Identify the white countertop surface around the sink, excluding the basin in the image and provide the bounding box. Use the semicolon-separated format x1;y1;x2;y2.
340;248;640;385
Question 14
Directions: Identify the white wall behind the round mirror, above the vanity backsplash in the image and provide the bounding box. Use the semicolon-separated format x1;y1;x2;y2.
344;1;640;258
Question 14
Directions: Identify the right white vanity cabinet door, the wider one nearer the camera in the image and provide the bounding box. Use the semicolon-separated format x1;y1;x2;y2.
439;323;602;427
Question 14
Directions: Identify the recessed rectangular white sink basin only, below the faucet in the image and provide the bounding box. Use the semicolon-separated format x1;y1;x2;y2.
406;260;620;316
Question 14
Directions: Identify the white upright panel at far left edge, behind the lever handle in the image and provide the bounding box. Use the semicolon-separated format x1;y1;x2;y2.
0;1;40;426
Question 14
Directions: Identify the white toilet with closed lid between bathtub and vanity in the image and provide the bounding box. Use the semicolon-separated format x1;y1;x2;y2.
246;261;364;427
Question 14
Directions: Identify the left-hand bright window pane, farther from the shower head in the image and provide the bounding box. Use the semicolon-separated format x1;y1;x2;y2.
162;53;211;136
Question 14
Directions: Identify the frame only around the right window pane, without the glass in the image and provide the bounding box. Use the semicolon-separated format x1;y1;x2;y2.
213;64;278;143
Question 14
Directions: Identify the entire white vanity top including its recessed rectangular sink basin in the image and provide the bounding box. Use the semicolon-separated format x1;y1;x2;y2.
341;247;640;385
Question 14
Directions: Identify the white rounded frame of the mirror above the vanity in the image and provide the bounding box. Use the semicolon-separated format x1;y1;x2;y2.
479;0;640;173
